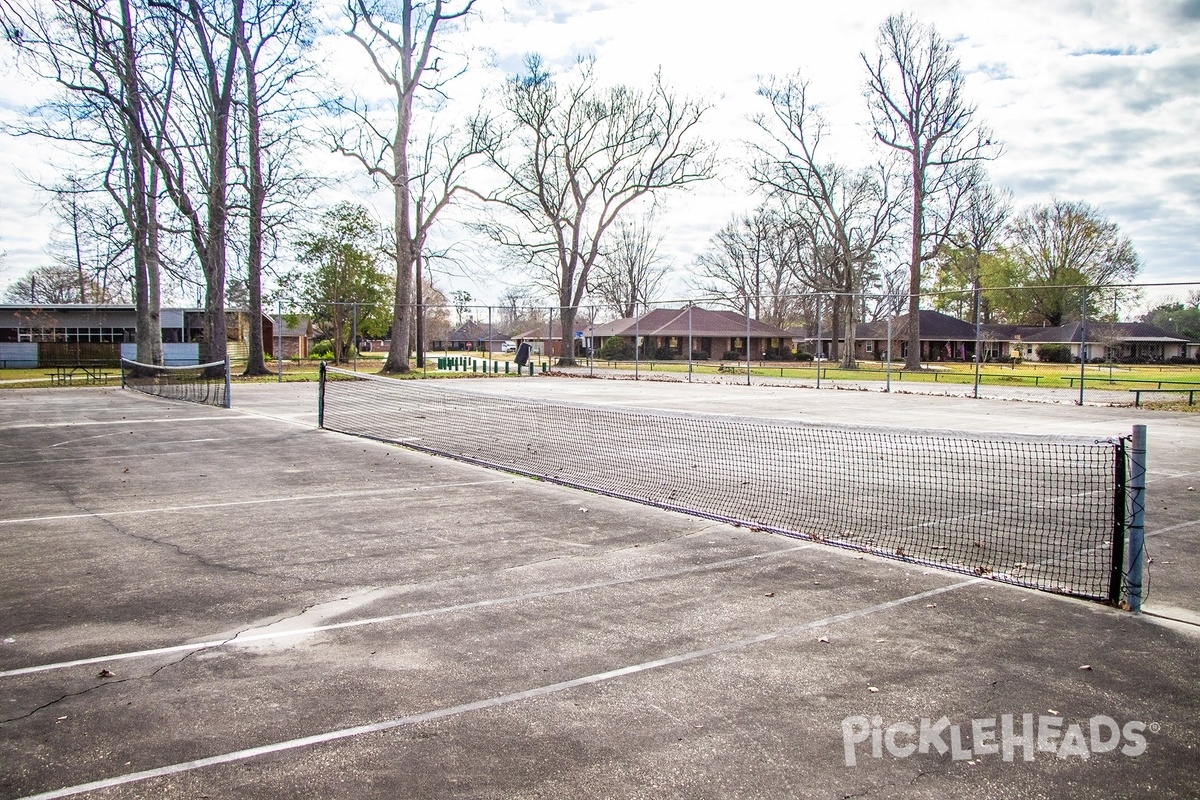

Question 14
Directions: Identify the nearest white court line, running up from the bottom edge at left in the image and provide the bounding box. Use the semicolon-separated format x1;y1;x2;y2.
16;578;983;800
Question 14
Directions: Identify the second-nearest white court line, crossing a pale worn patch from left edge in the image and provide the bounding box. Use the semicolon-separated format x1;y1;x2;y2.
0;542;817;678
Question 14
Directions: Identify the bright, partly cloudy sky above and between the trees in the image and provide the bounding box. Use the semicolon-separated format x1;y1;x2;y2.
0;0;1200;309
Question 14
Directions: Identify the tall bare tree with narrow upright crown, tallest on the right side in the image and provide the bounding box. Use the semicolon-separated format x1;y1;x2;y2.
862;14;998;369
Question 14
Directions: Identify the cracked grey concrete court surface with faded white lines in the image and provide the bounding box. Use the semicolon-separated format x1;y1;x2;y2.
0;379;1200;798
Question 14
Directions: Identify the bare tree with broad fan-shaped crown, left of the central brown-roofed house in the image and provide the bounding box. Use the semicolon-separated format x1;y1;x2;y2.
485;56;715;365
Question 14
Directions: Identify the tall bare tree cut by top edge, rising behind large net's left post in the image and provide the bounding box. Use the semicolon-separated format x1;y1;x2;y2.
335;0;479;373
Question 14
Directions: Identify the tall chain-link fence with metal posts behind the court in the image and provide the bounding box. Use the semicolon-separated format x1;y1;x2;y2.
270;283;1200;402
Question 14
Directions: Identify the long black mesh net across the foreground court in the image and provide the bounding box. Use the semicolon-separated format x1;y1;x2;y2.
319;367;1126;602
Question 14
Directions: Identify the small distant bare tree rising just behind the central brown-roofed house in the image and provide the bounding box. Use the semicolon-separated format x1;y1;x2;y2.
589;213;667;318
